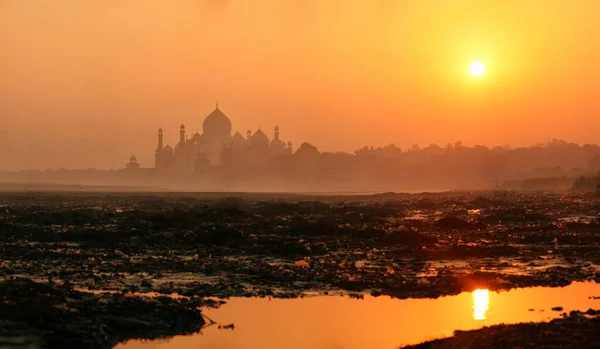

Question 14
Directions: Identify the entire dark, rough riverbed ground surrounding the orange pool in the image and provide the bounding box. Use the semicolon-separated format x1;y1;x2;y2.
0;192;600;348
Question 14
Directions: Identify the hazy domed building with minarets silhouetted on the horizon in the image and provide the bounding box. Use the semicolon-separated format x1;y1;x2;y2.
154;103;292;172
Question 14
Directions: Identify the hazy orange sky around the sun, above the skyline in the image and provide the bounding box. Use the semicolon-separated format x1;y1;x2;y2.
0;0;600;169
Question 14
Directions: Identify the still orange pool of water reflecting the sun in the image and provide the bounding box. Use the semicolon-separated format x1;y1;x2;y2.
114;283;600;349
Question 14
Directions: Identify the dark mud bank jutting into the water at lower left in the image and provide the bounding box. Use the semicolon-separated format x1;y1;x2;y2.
0;279;205;348
